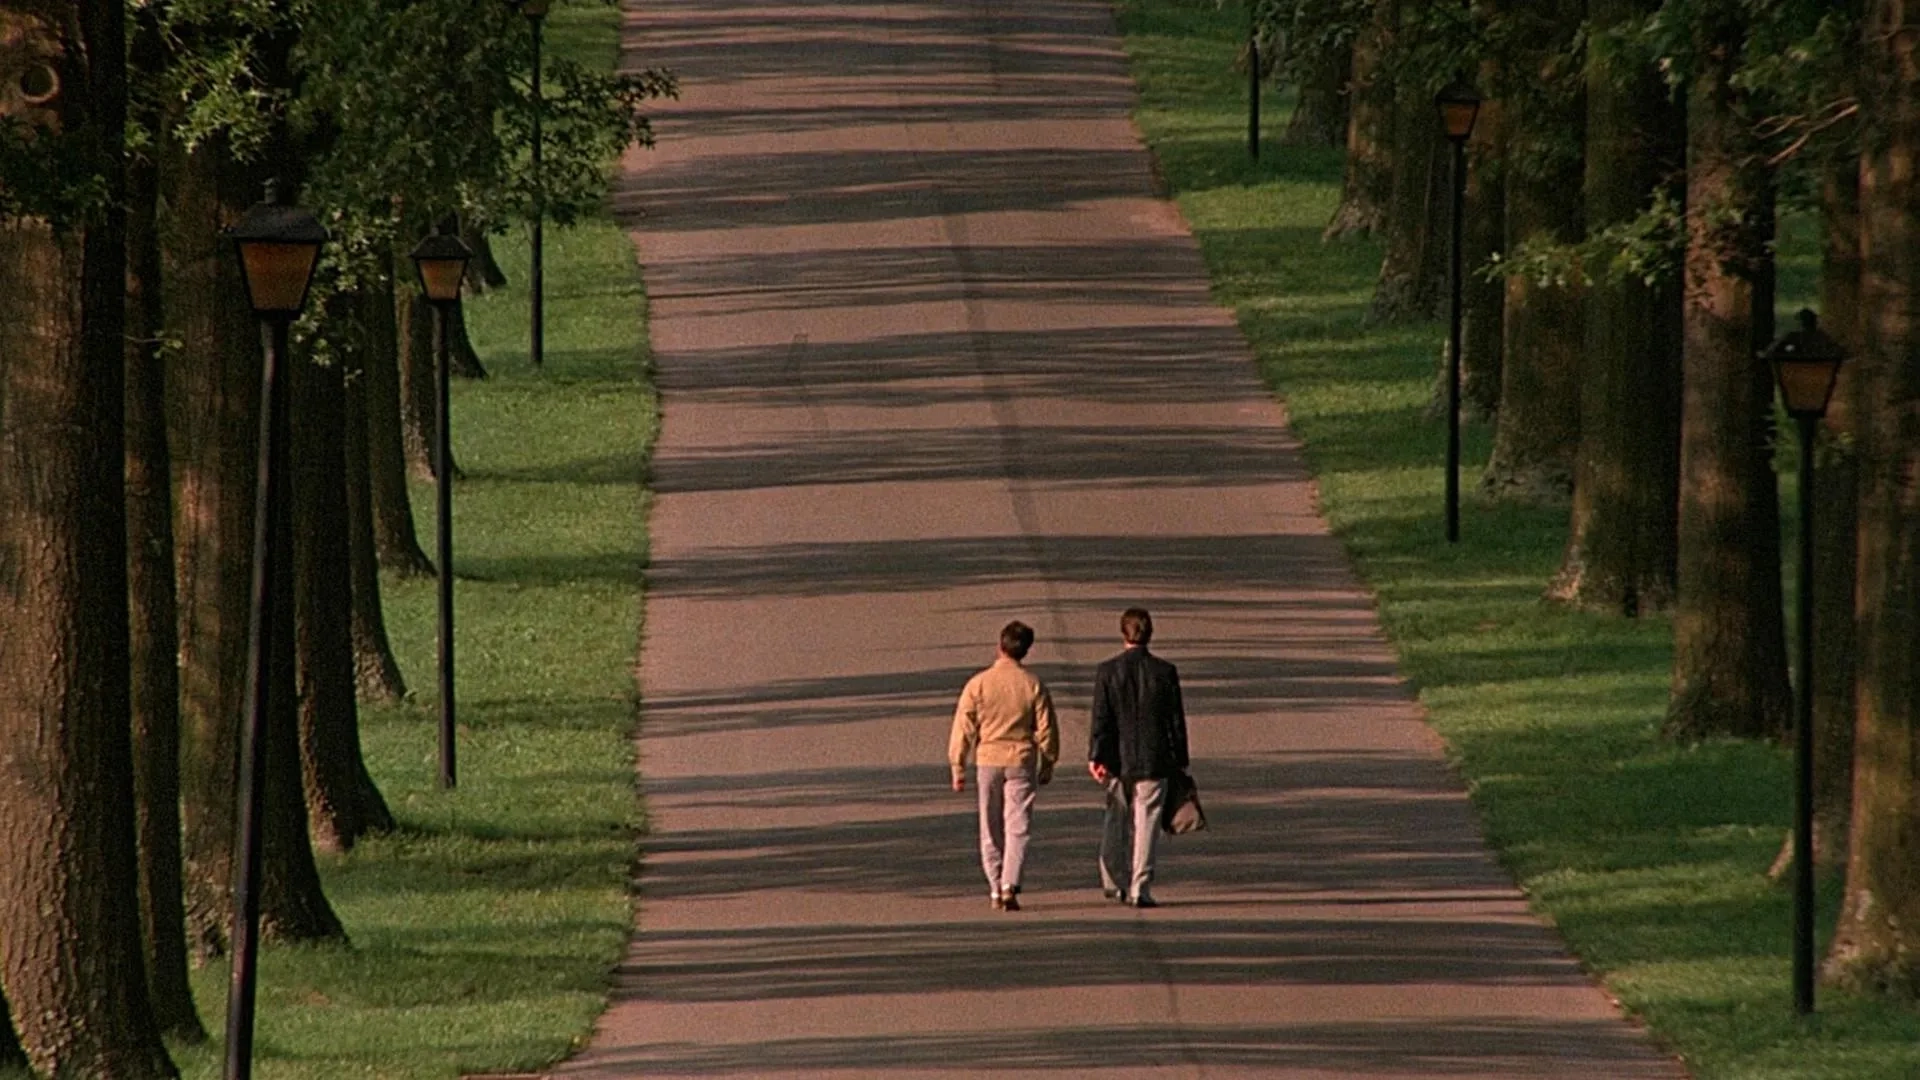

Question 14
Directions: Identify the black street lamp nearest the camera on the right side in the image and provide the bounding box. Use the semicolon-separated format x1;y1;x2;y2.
1763;309;1847;1015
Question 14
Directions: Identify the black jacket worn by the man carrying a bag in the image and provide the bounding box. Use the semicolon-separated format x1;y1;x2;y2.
1087;648;1187;780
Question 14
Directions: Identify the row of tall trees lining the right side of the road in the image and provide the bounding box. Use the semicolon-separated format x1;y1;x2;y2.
1256;0;1920;995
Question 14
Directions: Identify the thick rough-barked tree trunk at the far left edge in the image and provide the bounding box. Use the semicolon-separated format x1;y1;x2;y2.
0;0;177;1080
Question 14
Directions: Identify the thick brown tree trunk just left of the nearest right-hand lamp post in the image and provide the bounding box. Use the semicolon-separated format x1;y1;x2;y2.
1665;16;1791;740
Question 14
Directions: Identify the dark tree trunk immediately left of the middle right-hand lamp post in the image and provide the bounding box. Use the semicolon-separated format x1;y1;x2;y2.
1367;50;1452;323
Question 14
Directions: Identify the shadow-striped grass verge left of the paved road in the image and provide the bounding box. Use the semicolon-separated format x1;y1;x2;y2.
179;6;657;1080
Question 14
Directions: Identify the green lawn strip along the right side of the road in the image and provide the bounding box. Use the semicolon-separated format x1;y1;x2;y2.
1117;0;1920;1080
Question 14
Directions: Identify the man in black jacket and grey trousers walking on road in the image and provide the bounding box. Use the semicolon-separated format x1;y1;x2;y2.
1087;607;1187;907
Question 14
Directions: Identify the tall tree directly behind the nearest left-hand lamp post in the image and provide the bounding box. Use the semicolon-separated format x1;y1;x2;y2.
161;0;338;955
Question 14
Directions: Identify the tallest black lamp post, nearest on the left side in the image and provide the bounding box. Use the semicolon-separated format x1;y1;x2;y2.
225;183;326;1080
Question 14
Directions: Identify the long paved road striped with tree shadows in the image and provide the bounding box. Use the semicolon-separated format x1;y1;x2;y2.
561;0;1680;1080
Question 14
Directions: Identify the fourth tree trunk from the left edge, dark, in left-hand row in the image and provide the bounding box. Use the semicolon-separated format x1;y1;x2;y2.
294;345;394;851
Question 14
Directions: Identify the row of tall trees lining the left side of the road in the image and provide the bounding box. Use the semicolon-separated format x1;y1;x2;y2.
0;0;672;1080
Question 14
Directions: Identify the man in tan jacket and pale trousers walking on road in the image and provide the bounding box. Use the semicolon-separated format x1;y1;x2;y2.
947;619;1060;911
